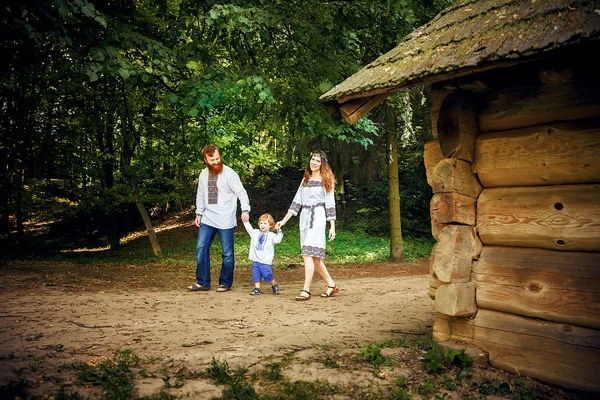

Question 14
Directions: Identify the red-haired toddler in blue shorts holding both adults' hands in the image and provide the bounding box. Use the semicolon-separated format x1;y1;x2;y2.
244;214;283;296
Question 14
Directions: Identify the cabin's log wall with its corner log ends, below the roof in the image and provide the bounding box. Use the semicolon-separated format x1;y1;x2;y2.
424;63;600;393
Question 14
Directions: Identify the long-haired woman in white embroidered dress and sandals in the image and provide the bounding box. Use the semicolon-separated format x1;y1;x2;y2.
276;151;339;301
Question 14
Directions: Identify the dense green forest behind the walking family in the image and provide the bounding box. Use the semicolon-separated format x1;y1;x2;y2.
0;0;452;261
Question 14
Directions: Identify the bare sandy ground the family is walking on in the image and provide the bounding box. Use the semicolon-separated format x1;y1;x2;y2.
0;261;434;398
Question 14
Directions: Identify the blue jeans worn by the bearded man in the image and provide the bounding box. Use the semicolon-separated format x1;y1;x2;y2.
196;224;235;288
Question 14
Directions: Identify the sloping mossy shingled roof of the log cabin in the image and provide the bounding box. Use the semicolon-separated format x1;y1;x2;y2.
320;0;600;122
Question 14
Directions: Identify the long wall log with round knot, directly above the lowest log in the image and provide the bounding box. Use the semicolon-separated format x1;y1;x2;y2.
474;246;600;329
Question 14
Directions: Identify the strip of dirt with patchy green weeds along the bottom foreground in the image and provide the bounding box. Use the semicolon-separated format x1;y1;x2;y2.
0;334;578;400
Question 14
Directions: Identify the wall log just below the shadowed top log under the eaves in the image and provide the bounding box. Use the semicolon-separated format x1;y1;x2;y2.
473;119;600;188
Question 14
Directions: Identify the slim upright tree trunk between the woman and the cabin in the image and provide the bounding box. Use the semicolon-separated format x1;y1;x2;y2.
385;104;404;262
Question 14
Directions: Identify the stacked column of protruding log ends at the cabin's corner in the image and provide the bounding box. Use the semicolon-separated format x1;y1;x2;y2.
424;86;483;317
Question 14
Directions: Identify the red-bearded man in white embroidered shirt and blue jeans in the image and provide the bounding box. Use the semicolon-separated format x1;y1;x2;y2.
188;144;250;292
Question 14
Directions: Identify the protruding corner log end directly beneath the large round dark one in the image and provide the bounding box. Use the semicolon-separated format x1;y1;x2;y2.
430;158;483;198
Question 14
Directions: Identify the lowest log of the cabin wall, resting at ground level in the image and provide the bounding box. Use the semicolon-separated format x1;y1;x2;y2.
433;308;600;393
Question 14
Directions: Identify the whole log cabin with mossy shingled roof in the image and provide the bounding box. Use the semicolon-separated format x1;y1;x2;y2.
320;0;600;393
